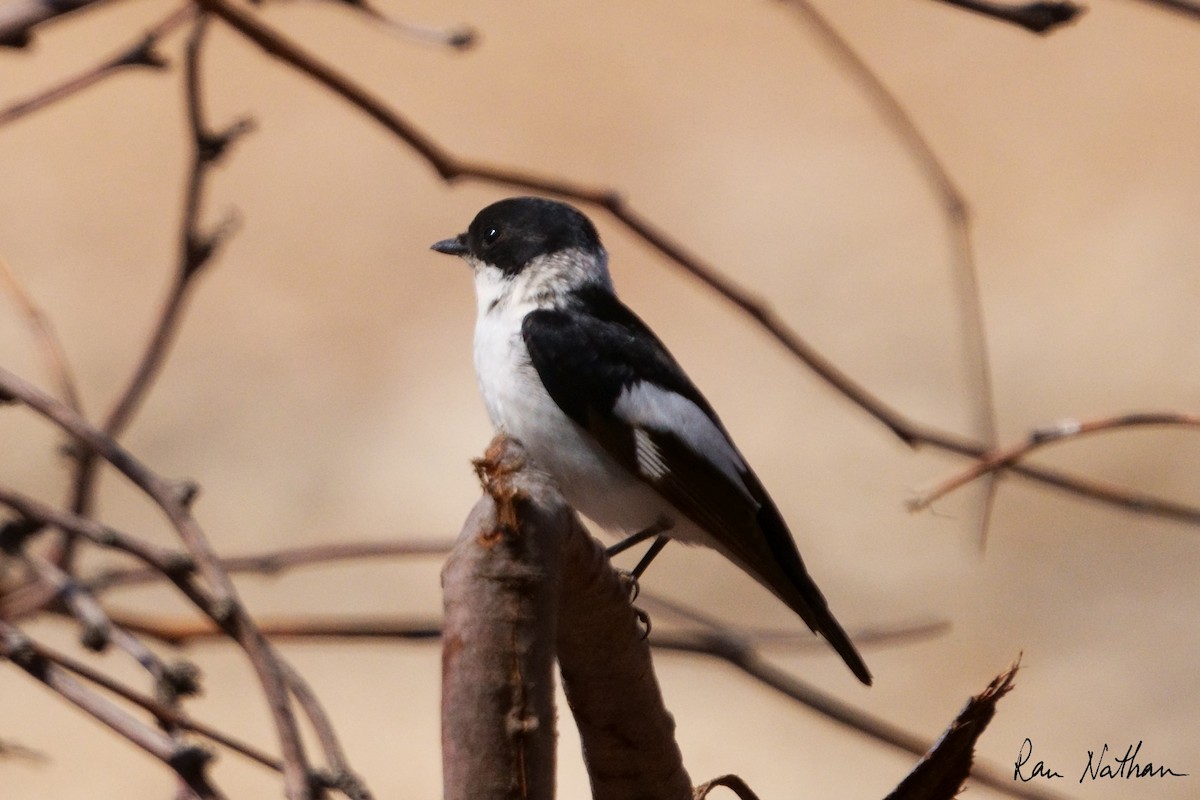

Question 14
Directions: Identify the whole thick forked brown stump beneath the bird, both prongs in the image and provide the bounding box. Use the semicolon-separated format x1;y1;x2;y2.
442;437;691;800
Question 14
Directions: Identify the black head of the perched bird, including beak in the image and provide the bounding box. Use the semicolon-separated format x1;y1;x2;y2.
433;197;600;275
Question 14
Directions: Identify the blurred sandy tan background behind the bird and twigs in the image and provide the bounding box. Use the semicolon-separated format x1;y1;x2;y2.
0;0;1200;800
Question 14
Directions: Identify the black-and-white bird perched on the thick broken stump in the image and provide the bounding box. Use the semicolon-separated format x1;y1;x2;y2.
432;197;871;685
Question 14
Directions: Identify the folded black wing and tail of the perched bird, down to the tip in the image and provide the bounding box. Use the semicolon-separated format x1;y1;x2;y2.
522;287;870;684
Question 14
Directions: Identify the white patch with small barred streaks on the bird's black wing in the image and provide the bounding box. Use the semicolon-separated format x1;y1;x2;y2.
613;381;750;498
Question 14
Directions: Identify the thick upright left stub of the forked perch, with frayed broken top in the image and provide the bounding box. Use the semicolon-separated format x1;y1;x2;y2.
442;438;572;800
